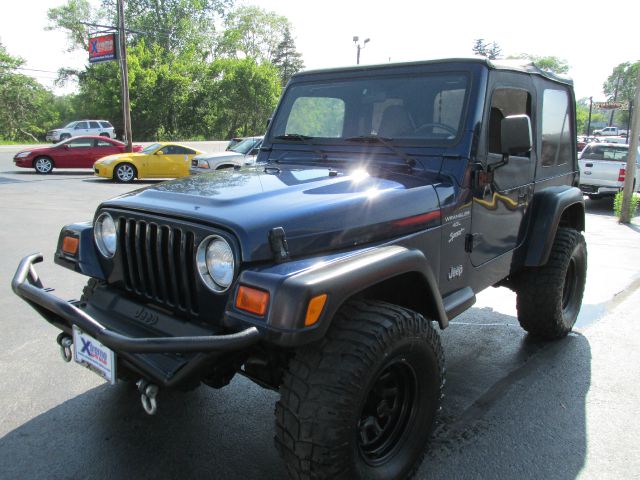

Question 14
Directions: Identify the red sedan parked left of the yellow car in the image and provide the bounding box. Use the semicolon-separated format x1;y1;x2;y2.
13;136;142;173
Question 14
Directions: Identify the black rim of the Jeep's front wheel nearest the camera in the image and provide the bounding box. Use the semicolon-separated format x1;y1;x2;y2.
358;359;418;466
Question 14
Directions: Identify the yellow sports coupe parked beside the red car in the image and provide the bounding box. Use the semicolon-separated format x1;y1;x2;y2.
93;142;204;183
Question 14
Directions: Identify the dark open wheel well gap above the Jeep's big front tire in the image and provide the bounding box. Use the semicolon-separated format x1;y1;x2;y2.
356;272;438;321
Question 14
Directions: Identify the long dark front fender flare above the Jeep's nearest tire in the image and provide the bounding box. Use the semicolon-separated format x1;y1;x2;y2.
226;245;448;346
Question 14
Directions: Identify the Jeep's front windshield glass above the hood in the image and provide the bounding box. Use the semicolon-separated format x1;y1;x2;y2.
270;74;469;144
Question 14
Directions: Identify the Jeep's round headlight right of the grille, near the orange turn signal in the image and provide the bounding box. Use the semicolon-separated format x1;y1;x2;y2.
196;235;234;292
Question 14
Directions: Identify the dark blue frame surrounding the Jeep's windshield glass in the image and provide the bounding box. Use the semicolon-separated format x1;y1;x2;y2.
265;70;475;148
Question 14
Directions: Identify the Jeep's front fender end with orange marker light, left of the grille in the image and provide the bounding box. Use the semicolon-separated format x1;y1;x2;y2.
54;222;106;280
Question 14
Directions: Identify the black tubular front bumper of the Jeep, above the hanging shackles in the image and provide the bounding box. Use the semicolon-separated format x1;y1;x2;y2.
11;253;261;387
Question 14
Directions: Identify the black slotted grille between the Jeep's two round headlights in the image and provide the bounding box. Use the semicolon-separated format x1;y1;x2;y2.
118;218;198;314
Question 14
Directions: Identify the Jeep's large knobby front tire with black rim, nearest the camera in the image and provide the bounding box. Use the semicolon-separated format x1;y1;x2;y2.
275;301;444;480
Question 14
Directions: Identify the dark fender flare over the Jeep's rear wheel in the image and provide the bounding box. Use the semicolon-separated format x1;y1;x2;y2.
523;186;585;267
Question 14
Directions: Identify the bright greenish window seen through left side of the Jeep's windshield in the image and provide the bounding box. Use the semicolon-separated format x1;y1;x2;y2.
285;97;345;138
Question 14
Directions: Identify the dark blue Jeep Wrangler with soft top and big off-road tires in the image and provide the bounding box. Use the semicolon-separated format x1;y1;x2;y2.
13;59;587;479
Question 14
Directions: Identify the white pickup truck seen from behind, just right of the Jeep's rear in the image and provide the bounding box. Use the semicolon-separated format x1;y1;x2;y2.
578;143;640;199
